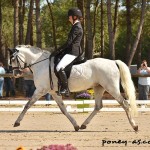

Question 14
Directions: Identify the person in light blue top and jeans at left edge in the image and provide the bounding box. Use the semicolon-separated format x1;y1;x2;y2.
0;62;5;98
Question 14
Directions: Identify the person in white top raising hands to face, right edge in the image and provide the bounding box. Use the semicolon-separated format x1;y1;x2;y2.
138;60;150;100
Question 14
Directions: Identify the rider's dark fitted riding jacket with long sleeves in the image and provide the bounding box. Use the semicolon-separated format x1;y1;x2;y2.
59;22;83;56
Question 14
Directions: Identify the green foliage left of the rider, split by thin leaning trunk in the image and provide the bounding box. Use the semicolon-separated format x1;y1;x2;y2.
41;0;75;47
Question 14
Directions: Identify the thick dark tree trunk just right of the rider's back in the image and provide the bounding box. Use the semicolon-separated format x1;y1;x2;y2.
85;0;93;59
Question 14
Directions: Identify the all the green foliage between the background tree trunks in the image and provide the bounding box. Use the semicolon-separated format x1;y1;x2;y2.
1;0;150;62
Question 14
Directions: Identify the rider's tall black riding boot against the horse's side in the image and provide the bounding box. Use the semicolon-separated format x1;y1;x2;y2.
58;69;70;97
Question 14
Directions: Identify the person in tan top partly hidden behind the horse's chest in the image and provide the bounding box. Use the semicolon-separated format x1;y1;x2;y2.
23;68;35;99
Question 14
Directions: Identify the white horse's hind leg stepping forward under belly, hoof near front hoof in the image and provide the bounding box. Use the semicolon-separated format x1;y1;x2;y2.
80;85;105;129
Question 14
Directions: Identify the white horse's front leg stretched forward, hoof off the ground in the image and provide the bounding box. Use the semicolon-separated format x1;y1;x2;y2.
14;90;42;127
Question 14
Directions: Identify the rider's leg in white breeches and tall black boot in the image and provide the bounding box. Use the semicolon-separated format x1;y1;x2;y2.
56;54;76;96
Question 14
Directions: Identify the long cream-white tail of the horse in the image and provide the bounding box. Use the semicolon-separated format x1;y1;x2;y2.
116;60;137;115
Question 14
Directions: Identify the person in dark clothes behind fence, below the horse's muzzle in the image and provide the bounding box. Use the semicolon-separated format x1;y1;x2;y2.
4;66;16;97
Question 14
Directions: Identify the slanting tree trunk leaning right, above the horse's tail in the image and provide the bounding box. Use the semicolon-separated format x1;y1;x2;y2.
128;0;146;66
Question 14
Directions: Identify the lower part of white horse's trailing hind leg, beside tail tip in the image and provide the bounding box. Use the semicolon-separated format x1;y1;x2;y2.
117;95;138;131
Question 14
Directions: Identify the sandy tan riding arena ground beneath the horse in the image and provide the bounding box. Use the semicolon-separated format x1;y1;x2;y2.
0;112;150;150
